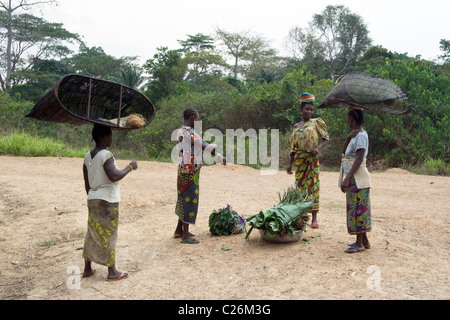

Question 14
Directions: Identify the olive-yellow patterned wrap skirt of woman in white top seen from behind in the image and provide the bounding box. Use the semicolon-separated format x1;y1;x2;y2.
83;200;119;267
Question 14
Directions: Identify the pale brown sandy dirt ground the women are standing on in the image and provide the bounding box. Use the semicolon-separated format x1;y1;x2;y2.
0;157;450;300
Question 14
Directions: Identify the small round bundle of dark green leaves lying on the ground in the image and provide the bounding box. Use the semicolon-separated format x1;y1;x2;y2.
209;205;245;236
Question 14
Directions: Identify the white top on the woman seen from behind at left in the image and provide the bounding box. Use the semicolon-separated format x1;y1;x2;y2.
84;149;120;203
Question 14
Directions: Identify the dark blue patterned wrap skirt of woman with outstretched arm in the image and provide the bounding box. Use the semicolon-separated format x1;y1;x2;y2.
175;170;200;224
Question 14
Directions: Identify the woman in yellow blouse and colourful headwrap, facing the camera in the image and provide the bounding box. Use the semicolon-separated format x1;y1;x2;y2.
286;93;330;229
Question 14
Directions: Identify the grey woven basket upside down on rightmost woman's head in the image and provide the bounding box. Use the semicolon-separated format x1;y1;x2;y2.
318;72;411;115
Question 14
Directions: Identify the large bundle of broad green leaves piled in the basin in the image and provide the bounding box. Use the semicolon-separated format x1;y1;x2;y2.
245;186;314;239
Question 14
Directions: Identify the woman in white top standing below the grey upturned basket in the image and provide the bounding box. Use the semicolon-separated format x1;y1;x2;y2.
339;107;372;253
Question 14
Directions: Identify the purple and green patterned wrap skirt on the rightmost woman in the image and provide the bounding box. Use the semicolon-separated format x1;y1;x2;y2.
347;178;372;235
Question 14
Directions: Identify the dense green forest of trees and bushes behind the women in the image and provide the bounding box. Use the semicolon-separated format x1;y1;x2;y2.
0;1;450;175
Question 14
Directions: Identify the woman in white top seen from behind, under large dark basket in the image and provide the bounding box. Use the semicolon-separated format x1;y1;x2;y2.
83;125;137;281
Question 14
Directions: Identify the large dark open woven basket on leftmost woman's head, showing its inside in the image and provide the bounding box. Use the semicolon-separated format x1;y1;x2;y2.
26;75;156;131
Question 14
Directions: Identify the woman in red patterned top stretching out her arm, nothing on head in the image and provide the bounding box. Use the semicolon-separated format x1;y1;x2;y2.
174;109;227;244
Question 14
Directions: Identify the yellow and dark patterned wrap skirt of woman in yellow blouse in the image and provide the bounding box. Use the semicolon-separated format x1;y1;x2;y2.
294;151;320;213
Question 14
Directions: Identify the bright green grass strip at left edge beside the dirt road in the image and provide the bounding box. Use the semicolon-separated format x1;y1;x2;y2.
0;133;89;158
